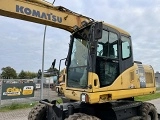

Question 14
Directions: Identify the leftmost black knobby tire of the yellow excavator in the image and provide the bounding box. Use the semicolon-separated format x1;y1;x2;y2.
28;103;47;120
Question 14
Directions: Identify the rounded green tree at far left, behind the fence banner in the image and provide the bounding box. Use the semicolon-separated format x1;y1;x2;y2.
1;66;17;79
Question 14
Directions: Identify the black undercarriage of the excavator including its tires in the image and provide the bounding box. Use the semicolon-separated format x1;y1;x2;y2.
28;99;160;120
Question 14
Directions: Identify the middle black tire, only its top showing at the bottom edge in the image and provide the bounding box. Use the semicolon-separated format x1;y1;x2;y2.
65;113;100;120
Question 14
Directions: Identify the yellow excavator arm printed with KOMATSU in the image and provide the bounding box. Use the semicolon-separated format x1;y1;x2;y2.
0;0;93;32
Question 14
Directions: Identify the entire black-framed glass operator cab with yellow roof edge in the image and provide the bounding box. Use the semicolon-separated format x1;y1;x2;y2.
66;23;133;89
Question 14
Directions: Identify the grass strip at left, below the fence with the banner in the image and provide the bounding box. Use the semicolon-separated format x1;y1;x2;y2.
0;102;37;112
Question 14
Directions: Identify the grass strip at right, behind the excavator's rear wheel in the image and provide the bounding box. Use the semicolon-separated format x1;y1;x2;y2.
135;92;160;101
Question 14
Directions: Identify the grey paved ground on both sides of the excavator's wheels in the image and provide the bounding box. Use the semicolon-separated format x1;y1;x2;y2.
0;99;160;120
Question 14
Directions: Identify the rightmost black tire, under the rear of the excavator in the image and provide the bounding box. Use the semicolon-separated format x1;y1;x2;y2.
140;103;158;120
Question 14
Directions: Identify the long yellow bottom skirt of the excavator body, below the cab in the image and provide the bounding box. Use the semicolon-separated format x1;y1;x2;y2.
65;87;156;104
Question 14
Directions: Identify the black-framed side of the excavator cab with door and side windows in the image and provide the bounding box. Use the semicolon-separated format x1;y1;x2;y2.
95;25;133;87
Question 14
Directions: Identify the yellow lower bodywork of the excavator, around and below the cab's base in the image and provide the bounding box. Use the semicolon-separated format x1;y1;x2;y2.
65;64;156;104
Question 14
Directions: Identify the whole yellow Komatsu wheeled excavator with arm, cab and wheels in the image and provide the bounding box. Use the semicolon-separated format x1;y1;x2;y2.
0;0;158;120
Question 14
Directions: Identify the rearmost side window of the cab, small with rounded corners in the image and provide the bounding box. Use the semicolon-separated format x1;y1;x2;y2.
121;36;131;59
